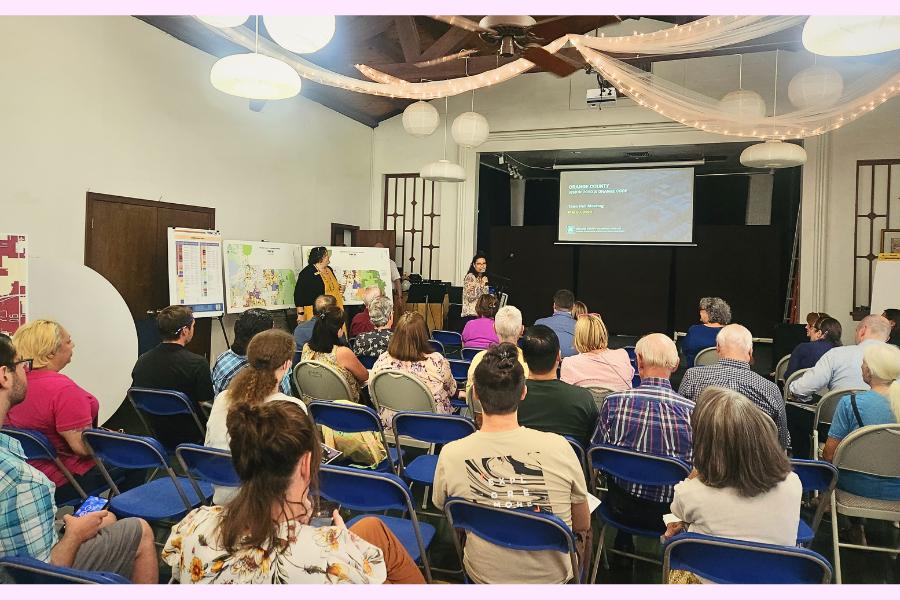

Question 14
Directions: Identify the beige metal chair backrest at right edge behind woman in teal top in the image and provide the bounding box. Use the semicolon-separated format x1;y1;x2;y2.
832;423;900;477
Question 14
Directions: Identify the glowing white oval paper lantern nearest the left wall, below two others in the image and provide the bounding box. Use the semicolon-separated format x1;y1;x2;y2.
209;54;301;100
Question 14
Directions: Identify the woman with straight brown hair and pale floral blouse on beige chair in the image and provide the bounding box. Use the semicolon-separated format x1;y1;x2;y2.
372;312;456;429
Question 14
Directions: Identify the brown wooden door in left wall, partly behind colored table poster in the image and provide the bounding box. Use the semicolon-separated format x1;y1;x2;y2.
84;192;215;358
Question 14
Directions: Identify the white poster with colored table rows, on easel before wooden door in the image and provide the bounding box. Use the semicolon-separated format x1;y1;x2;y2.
168;227;225;317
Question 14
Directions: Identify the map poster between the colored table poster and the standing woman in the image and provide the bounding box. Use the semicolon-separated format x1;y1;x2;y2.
224;240;300;313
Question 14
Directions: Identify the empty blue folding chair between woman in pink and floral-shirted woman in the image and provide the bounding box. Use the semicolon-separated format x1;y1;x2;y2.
81;429;213;522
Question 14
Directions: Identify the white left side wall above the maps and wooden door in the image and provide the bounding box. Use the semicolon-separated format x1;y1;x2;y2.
0;17;373;356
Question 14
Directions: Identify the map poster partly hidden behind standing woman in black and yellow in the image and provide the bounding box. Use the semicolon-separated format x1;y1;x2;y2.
297;246;391;305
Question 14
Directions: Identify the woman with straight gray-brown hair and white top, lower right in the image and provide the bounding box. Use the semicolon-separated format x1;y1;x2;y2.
666;387;803;583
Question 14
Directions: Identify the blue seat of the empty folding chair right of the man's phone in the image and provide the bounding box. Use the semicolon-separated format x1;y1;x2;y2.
109;477;213;521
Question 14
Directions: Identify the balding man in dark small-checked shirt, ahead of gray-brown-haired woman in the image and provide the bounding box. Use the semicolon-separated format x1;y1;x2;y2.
678;324;791;448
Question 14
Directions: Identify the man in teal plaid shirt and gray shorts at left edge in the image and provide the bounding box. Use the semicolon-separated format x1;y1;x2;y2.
0;332;159;580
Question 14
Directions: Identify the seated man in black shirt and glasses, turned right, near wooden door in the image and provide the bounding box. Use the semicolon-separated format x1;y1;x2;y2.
131;306;214;447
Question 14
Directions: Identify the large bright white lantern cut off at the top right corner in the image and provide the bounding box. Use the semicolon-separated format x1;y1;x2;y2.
802;15;900;56
